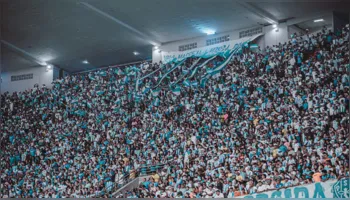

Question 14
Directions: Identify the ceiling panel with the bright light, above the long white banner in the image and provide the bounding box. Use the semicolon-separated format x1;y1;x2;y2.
86;0;265;43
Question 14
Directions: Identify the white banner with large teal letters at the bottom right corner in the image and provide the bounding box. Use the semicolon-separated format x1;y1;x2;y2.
235;178;350;199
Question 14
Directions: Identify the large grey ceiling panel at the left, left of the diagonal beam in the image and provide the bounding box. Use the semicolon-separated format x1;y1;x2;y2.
3;0;148;71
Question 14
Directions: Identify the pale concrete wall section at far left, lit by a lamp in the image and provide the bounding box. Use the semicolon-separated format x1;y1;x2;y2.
1;67;53;93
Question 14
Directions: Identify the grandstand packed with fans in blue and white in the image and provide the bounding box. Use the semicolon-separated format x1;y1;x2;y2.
0;25;350;198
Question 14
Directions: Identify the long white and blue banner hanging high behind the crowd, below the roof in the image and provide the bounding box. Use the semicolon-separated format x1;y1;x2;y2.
162;34;262;64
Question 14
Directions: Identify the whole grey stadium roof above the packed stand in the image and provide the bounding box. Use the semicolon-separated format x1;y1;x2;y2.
0;0;350;72
